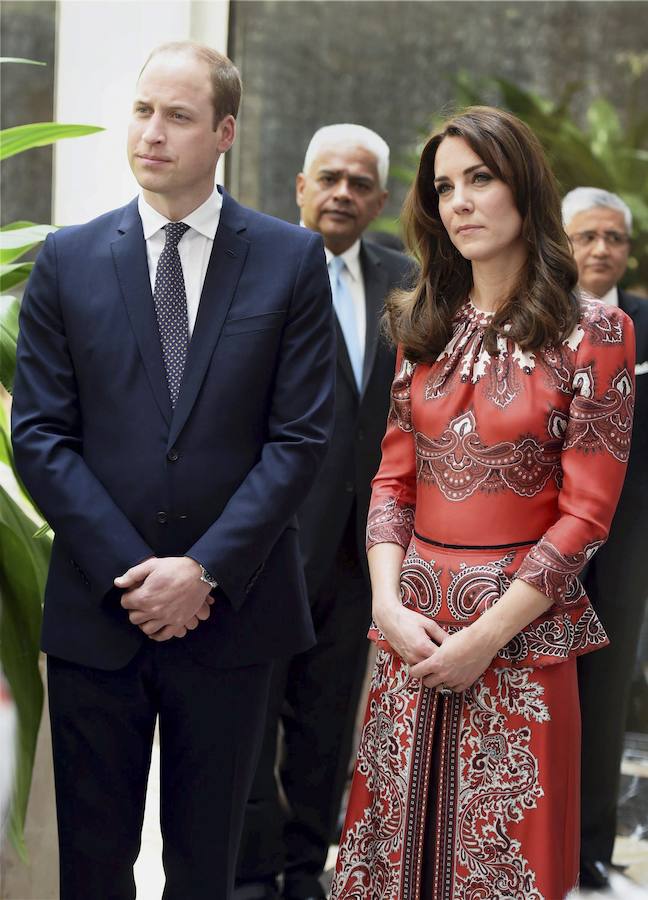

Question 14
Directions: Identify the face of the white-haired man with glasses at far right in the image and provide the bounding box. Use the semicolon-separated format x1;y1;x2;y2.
567;206;630;297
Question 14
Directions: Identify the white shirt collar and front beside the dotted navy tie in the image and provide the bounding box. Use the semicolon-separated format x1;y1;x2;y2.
137;187;223;337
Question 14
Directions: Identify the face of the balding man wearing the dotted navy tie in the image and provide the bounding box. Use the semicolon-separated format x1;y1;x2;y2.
128;52;235;215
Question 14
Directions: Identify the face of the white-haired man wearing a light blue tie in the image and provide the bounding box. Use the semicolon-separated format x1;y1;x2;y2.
297;145;387;255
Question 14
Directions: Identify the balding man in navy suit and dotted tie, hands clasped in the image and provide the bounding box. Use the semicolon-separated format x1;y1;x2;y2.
13;43;335;900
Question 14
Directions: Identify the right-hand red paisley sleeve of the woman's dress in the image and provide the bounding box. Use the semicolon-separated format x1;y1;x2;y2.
517;301;635;607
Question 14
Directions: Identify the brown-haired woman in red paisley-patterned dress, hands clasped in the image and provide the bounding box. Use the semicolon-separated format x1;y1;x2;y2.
332;107;634;900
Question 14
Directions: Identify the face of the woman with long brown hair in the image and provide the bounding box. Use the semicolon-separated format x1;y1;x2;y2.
434;137;526;264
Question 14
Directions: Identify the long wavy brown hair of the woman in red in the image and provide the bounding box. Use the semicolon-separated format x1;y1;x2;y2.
385;106;579;363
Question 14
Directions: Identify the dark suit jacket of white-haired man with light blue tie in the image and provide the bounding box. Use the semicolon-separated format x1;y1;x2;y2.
298;241;414;592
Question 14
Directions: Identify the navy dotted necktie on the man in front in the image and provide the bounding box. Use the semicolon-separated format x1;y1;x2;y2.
153;222;189;407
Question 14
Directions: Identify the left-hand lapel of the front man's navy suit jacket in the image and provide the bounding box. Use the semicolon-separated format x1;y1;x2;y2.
111;200;171;423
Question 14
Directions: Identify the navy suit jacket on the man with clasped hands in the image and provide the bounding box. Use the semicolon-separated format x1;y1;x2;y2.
13;194;334;669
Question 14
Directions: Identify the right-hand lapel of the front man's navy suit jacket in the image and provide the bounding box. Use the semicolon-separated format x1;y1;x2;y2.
169;194;250;446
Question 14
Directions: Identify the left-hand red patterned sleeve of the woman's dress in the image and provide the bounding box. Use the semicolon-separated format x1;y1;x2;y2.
367;347;416;550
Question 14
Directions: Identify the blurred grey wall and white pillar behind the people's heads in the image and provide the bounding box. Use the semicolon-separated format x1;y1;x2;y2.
1;0;648;232
